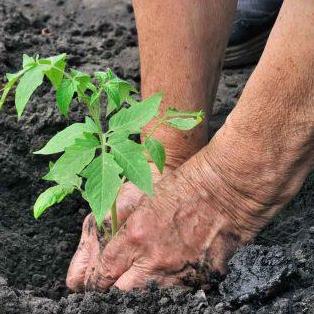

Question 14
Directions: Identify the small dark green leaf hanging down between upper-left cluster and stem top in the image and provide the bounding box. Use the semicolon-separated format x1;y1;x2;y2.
56;78;78;116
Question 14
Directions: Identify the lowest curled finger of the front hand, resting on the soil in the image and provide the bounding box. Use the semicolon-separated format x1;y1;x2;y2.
114;266;181;291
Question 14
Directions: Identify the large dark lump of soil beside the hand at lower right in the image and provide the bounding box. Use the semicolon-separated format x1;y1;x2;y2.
219;245;297;303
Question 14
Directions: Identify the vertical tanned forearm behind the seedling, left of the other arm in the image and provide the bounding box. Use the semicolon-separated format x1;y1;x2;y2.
133;0;236;167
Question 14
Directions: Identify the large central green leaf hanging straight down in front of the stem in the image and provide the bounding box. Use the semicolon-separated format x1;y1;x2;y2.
84;152;122;227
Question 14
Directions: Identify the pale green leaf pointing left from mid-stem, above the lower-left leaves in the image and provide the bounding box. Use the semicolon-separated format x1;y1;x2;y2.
34;117;97;155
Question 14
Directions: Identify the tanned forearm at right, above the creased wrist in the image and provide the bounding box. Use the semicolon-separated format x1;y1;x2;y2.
227;0;314;158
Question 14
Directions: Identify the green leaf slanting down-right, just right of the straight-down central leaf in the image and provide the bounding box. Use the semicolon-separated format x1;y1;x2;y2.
109;140;153;195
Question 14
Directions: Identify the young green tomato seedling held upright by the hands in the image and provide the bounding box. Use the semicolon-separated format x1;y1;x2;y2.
0;54;203;235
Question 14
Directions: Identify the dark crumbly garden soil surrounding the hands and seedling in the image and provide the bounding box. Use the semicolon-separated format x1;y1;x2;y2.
0;0;314;314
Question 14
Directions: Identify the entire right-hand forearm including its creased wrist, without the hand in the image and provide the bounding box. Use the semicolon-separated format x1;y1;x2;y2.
189;1;314;233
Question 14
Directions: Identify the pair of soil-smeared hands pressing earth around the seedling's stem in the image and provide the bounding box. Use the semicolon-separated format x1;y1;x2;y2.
67;157;238;291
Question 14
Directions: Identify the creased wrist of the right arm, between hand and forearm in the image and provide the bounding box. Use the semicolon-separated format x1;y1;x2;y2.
185;118;313;242
